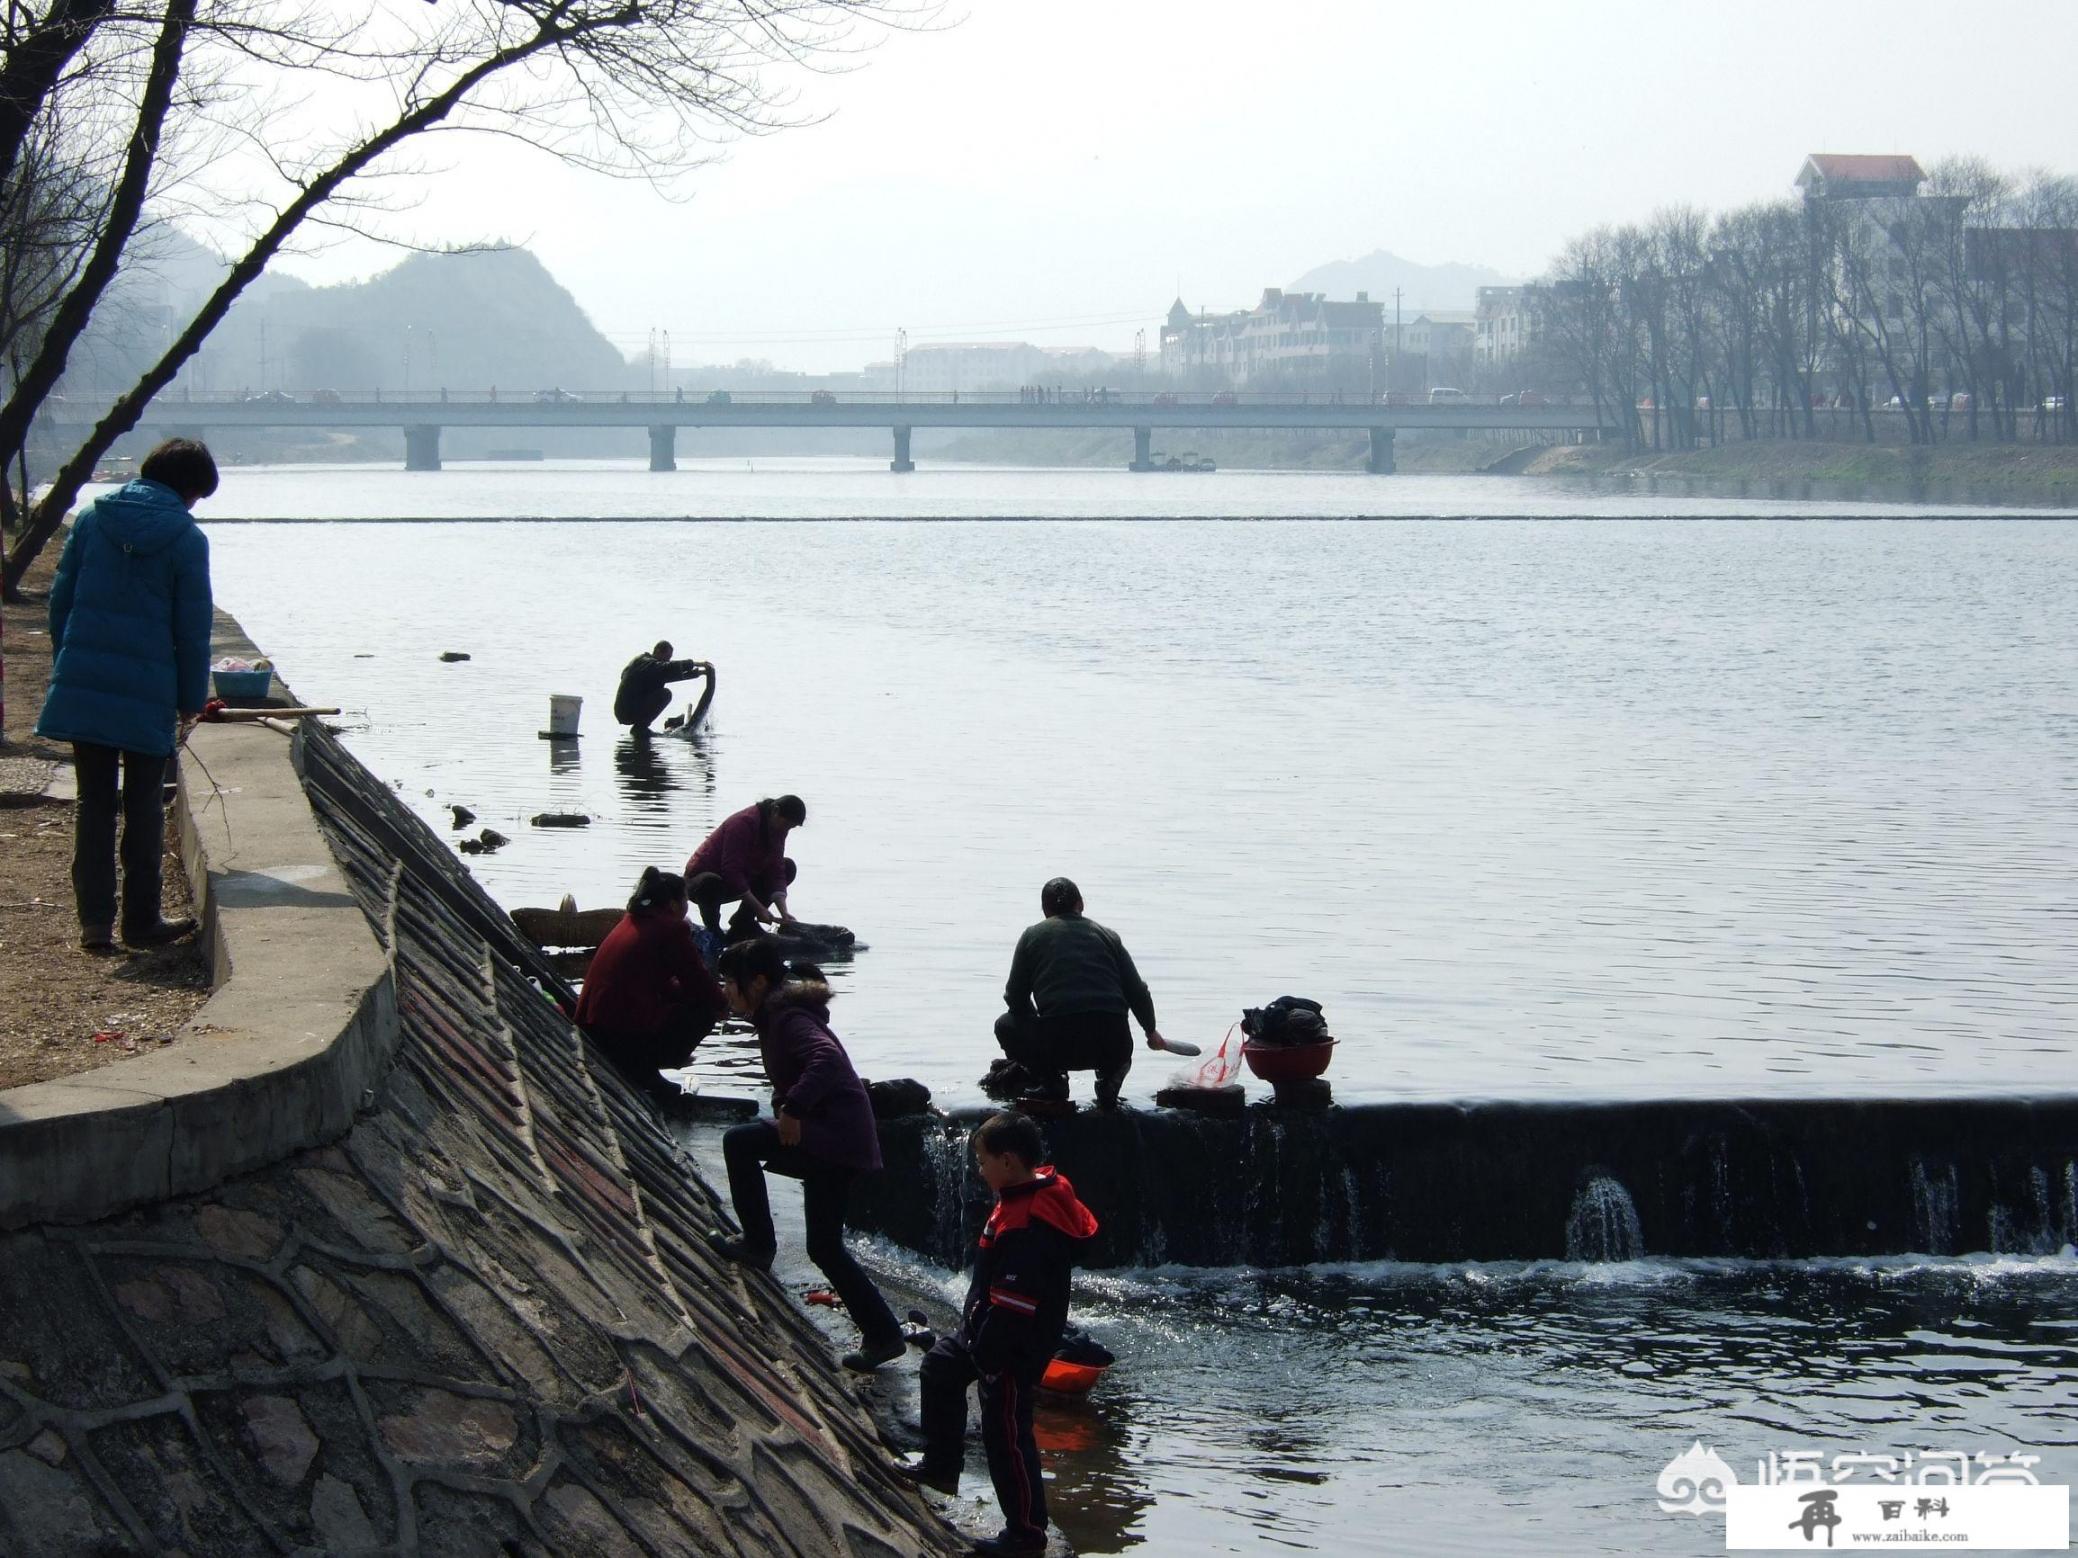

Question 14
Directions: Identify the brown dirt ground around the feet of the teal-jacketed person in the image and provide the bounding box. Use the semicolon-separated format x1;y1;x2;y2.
0;544;210;1089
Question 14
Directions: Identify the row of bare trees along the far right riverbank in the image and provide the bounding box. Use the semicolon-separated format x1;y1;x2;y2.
1521;160;2078;449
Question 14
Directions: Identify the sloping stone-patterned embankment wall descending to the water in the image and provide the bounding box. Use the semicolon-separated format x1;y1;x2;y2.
0;623;960;1558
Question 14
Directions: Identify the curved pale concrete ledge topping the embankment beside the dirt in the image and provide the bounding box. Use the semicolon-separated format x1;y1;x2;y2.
0;613;397;1228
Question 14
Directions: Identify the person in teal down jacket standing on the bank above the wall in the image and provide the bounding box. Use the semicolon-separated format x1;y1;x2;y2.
35;438;216;951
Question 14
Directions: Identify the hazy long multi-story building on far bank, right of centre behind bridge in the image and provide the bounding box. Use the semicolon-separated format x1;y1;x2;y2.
1162;287;1386;384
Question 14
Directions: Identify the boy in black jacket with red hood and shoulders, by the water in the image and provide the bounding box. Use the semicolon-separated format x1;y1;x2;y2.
900;1113;1097;1554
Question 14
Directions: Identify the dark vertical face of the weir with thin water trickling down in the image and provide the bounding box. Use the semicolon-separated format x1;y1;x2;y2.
854;1097;2078;1267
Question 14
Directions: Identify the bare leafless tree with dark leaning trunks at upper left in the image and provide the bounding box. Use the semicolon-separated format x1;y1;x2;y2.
0;0;929;590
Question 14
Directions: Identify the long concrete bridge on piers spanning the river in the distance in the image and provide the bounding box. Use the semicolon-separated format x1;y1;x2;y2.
73;388;1617;474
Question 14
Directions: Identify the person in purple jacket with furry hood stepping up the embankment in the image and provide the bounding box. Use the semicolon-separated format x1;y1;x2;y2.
707;941;904;1373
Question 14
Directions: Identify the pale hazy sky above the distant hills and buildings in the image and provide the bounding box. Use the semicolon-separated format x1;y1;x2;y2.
287;0;2078;368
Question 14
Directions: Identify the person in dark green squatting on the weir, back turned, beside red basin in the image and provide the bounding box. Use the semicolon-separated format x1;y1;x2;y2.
995;877;1168;1109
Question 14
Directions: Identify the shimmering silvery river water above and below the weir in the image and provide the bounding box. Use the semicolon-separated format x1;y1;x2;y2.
182;459;2078;1552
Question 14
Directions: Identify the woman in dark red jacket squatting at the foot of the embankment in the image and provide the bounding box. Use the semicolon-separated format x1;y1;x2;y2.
578;866;727;1095
